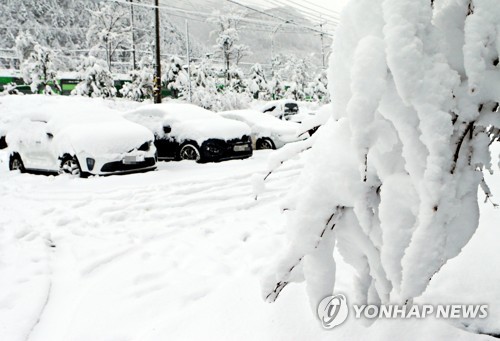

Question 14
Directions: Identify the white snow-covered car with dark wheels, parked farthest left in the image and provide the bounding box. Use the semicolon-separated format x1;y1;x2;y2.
6;96;156;177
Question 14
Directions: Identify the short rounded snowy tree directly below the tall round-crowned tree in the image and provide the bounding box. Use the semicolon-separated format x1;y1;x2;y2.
72;56;116;98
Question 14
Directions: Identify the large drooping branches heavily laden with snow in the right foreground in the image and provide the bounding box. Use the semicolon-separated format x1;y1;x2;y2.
263;0;500;316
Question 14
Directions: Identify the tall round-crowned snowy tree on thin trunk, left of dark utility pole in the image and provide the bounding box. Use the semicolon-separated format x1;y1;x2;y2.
87;1;131;71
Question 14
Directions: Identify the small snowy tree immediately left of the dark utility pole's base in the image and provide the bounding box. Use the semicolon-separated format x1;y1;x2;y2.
120;58;153;102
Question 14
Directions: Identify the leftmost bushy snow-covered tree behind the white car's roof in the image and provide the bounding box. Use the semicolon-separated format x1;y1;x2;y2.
21;44;61;95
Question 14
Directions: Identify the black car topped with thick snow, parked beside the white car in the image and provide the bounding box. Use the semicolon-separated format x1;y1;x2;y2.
124;102;253;162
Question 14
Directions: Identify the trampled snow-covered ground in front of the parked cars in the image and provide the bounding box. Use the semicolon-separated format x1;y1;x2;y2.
0;144;500;341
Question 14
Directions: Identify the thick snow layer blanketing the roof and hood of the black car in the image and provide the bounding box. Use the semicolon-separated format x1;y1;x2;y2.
124;102;250;145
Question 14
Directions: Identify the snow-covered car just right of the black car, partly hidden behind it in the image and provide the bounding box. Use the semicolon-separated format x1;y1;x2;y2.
219;109;309;149
